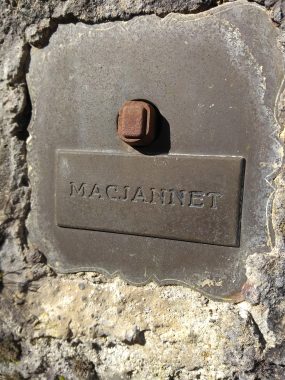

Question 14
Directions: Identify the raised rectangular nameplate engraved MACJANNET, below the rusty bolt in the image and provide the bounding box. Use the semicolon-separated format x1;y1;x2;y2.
56;151;244;247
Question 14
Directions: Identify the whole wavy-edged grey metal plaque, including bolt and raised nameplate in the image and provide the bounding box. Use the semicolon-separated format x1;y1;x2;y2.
27;1;284;299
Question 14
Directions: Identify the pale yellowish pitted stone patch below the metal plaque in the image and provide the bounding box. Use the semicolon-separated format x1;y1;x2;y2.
3;274;263;380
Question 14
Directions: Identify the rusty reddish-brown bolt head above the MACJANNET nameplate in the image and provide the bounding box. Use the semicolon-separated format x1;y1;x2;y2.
118;100;156;146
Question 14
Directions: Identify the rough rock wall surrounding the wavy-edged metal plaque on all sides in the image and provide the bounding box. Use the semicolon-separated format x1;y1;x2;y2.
0;0;285;380
